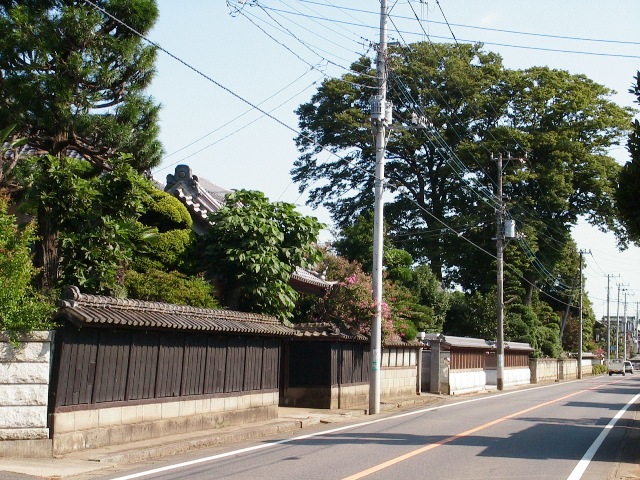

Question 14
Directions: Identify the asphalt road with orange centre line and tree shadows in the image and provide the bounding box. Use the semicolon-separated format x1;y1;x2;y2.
81;375;640;480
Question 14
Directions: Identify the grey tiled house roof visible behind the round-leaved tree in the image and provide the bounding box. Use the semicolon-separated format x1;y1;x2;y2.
164;165;331;295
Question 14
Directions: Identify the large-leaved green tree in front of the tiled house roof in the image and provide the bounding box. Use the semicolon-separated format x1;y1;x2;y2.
205;190;322;320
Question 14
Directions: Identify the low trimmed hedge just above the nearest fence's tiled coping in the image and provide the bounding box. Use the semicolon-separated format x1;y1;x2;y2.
125;270;218;308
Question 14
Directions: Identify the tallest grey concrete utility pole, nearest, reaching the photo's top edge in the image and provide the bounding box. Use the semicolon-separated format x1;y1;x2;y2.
369;0;392;415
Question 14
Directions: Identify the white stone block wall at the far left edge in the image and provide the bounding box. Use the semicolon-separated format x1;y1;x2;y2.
0;332;53;440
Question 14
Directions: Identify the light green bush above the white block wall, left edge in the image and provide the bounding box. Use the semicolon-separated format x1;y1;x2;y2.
0;198;55;338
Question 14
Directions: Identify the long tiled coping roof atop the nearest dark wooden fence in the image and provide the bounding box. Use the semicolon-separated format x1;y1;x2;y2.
56;287;296;336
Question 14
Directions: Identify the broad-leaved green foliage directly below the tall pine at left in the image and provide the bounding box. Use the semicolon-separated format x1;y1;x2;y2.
23;155;153;296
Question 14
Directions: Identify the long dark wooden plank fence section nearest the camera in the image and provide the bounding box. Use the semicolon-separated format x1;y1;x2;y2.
51;327;282;409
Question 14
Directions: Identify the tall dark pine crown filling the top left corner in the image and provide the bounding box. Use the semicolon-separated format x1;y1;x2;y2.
0;0;161;172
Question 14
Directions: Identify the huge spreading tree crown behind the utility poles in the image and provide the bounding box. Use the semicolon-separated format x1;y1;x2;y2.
292;43;631;312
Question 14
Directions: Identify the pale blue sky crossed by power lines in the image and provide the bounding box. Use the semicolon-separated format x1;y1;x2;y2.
142;0;640;317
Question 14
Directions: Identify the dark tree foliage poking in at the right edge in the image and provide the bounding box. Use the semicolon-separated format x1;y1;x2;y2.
616;72;640;244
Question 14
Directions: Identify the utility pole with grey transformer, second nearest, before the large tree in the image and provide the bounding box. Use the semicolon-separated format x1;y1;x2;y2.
494;154;504;390
